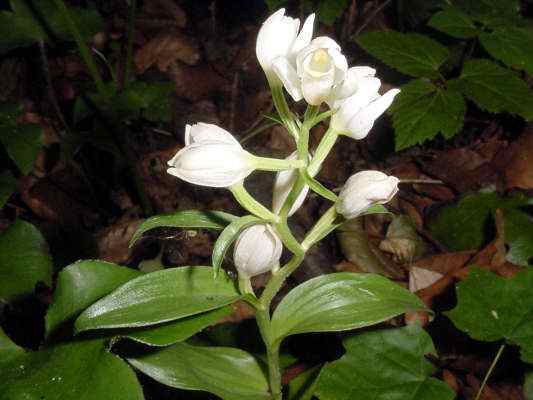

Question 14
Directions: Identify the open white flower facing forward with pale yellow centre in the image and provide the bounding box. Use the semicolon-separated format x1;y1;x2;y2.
273;36;357;105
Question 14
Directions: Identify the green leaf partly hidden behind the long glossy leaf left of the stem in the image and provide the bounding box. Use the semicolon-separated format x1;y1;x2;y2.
45;260;141;336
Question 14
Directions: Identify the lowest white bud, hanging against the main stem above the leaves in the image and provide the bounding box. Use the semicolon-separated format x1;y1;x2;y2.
233;224;283;278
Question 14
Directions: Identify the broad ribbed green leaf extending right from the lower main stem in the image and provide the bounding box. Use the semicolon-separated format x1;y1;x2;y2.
272;272;425;341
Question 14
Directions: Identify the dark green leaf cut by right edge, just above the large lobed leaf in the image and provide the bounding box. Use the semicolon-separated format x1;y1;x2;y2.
504;210;533;267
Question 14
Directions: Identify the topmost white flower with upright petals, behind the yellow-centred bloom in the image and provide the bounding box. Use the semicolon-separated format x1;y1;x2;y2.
255;8;315;84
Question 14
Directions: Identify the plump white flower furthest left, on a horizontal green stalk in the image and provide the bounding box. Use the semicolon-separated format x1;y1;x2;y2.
167;123;254;187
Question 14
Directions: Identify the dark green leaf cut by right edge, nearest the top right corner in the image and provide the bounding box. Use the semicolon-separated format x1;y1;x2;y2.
479;26;533;74
